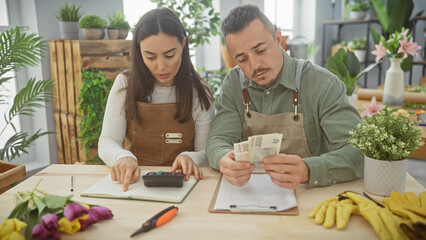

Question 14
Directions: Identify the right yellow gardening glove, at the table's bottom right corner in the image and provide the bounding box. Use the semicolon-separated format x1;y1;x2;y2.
346;192;408;240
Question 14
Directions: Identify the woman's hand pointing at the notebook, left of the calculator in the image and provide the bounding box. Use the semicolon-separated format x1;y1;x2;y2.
111;157;141;192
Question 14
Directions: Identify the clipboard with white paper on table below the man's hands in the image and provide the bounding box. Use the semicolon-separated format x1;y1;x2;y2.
209;174;299;215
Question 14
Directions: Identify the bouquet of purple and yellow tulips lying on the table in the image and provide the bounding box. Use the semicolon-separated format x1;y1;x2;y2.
0;182;113;240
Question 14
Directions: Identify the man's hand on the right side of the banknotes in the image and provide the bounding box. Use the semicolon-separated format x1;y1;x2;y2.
259;154;309;189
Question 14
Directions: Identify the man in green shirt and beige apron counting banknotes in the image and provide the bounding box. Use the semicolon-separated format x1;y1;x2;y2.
206;5;364;189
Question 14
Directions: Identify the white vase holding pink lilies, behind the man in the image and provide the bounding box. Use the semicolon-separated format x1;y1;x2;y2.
382;58;404;106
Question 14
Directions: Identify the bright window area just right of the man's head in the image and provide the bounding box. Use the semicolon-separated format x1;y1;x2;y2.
264;0;294;38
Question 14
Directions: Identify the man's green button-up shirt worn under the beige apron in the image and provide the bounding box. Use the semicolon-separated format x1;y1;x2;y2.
206;50;364;187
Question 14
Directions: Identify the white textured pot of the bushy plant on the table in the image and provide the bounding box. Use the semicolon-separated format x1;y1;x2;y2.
364;156;407;196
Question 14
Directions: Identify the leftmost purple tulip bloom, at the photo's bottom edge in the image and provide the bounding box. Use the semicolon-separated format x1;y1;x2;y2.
31;213;61;240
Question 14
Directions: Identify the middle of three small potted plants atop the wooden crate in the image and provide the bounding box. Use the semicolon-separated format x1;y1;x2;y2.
78;14;106;40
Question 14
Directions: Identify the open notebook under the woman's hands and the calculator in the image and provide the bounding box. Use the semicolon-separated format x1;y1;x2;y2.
80;171;198;203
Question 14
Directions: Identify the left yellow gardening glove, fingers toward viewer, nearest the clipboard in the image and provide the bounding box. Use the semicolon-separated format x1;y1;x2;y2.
309;193;358;230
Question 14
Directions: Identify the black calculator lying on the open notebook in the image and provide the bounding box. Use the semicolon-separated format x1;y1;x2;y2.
142;171;184;187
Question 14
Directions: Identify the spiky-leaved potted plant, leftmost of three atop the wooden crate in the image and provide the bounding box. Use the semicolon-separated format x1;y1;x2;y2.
56;3;81;39
